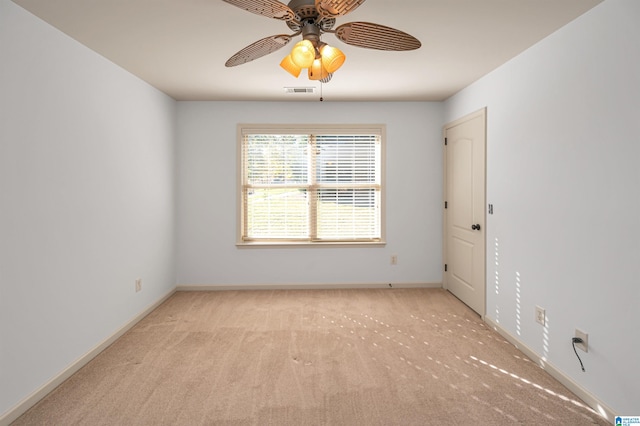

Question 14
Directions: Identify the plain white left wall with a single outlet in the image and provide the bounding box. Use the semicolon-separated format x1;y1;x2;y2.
0;0;176;418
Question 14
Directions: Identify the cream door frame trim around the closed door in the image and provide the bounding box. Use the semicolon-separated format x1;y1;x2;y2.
442;107;488;319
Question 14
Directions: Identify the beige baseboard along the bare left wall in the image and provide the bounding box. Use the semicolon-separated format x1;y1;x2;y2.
0;289;176;426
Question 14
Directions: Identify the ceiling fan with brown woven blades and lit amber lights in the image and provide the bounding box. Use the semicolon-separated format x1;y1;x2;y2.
223;0;421;83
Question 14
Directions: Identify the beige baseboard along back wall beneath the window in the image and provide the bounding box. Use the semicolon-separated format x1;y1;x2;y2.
176;283;442;291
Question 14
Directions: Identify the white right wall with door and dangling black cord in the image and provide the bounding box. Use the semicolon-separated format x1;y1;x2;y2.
445;0;640;415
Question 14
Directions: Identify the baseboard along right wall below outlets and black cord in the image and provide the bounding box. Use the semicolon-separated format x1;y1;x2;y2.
484;317;616;424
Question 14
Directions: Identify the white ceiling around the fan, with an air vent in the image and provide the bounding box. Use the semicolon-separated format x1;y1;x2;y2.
13;0;602;101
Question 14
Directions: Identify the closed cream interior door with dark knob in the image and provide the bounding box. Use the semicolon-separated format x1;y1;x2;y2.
443;109;486;316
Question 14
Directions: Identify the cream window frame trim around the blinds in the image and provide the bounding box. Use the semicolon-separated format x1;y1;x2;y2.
236;123;386;247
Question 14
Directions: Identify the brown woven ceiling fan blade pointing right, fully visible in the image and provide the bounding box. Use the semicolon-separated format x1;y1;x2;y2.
335;22;422;50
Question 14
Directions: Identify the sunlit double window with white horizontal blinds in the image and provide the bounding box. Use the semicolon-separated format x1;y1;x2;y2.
238;125;384;244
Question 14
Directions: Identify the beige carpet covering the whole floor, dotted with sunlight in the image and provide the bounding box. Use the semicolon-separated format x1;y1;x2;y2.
14;289;608;426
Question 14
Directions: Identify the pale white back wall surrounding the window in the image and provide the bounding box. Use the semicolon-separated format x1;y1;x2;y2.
178;101;443;286
